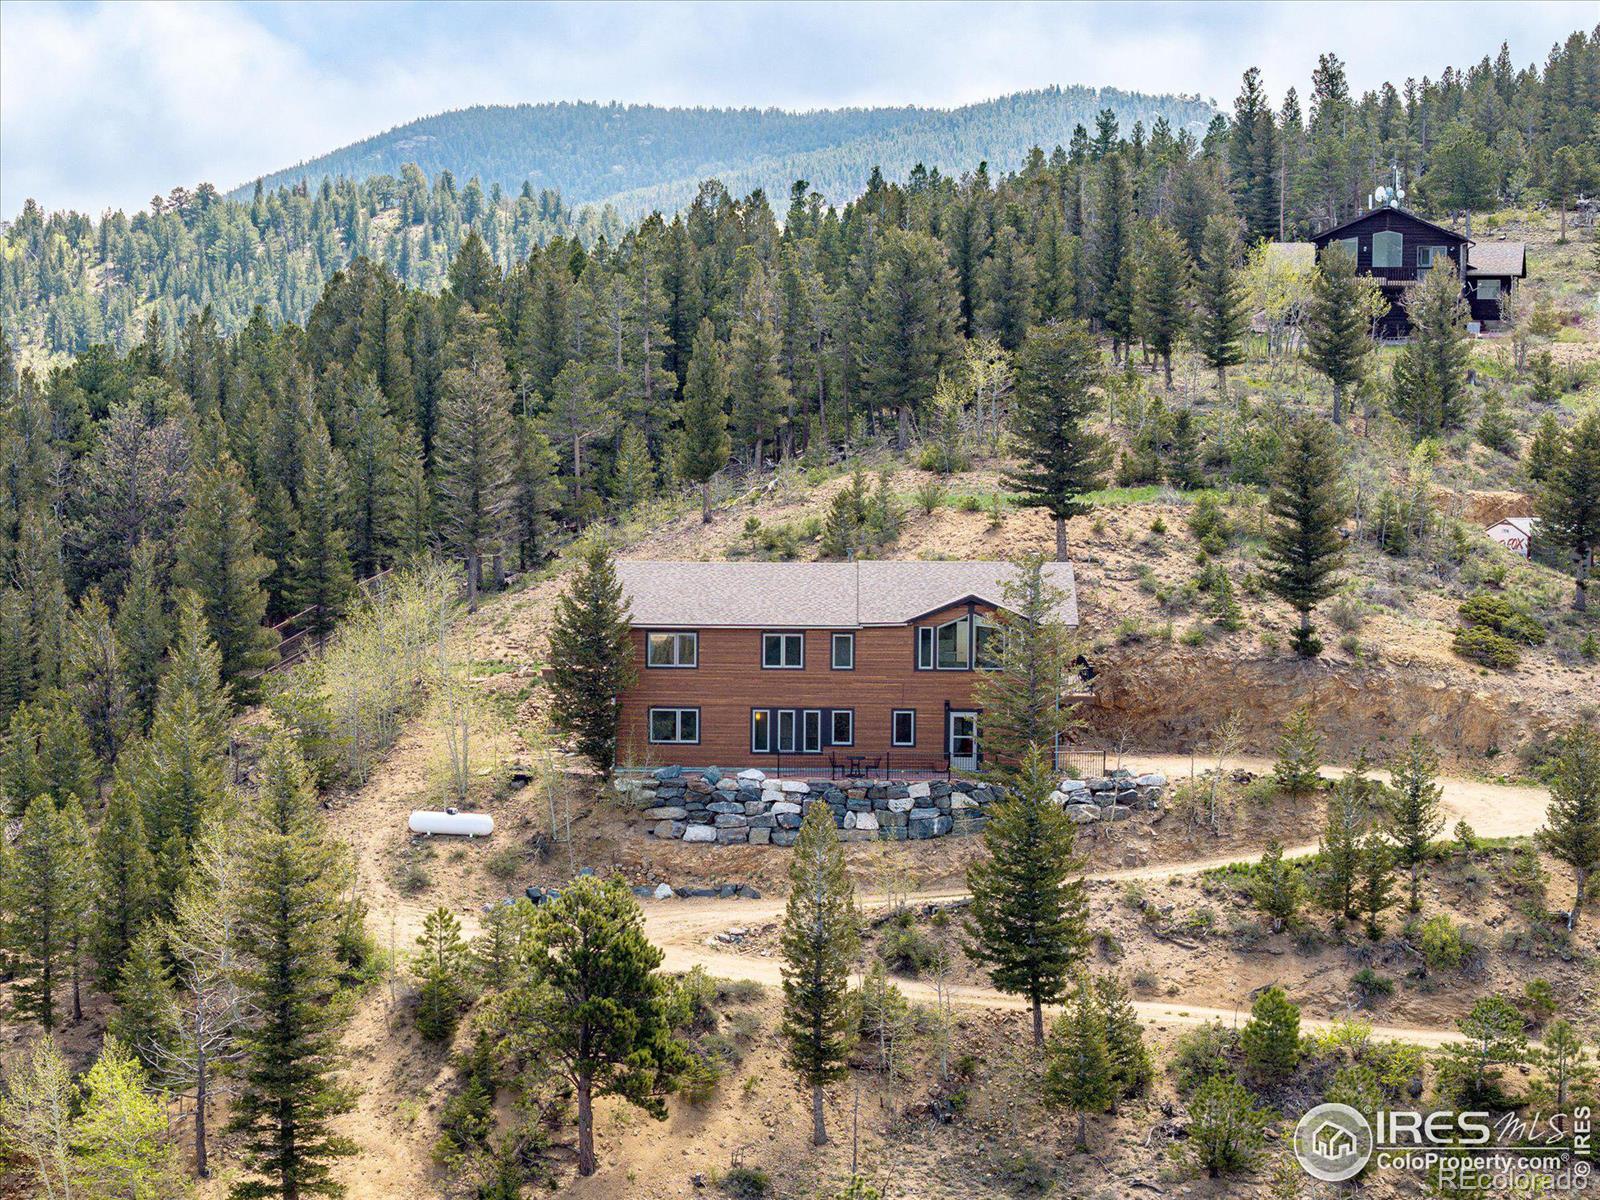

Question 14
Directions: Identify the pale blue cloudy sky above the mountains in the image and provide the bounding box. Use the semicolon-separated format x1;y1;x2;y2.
0;0;1597;216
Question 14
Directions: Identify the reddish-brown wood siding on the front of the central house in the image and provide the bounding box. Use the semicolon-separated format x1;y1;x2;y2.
618;605;992;774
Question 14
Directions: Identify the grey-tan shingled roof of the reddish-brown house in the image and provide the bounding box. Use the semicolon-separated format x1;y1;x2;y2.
616;560;1078;629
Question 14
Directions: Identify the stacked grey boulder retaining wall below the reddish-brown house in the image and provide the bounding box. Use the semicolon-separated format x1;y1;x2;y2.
616;766;1166;846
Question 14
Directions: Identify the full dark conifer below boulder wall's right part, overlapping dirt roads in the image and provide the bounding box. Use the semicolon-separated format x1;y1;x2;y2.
966;747;1088;1045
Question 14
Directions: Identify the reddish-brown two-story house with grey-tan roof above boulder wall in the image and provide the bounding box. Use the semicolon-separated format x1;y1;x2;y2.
618;562;1078;774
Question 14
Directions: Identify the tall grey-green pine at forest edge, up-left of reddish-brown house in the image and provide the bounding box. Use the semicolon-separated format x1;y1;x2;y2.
434;317;514;563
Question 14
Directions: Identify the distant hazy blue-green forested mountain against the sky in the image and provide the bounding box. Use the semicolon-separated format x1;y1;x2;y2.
234;86;1214;218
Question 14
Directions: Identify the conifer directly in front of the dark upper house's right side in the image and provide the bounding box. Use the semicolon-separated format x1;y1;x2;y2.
1390;270;1470;438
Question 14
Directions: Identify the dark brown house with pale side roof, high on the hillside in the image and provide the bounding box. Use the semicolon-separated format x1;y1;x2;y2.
1312;206;1526;338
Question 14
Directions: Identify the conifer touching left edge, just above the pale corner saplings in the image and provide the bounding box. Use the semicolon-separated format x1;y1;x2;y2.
5;795;85;1034
